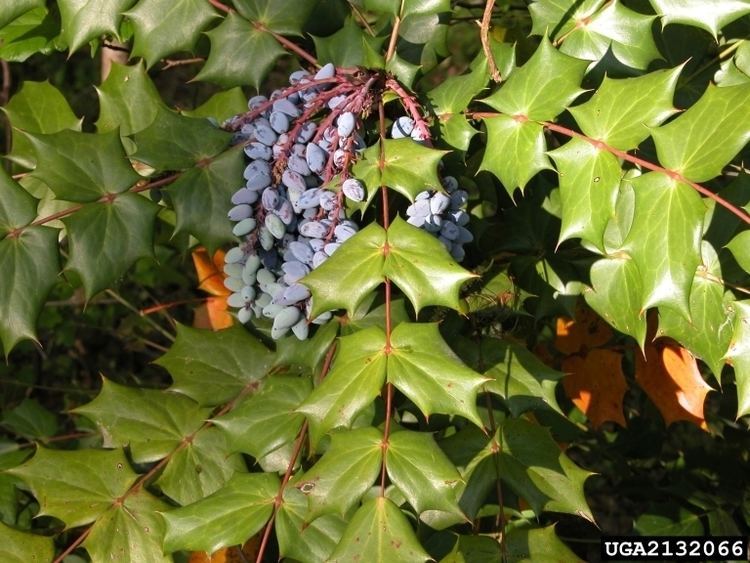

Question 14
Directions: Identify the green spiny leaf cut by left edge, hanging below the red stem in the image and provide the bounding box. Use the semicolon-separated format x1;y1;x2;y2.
0;227;60;357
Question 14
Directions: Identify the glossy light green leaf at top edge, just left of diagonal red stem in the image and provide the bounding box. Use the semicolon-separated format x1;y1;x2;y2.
125;0;218;67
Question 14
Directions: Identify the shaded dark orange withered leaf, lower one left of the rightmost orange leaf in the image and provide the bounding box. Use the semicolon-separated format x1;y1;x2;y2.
562;348;628;428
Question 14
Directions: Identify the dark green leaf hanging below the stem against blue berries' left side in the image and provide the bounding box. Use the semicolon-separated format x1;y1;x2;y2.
165;145;246;255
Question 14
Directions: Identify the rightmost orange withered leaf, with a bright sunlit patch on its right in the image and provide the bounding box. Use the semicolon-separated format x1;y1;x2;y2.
635;340;712;429
